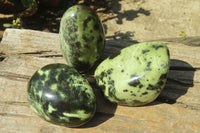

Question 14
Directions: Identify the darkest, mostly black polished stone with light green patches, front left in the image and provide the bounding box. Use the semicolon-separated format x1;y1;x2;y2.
28;64;96;127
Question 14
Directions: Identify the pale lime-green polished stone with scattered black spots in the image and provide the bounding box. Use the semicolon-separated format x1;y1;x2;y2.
95;42;170;106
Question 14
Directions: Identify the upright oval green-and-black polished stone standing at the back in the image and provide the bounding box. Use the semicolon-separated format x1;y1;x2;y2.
59;5;105;70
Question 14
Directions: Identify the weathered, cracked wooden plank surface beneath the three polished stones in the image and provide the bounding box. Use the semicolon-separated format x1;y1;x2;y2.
0;29;200;133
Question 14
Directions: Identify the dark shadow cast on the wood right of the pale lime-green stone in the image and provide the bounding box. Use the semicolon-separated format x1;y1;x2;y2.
157;59;195;104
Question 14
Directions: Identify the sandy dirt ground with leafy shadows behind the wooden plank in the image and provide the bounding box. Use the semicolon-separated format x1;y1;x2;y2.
0;0;200;42
